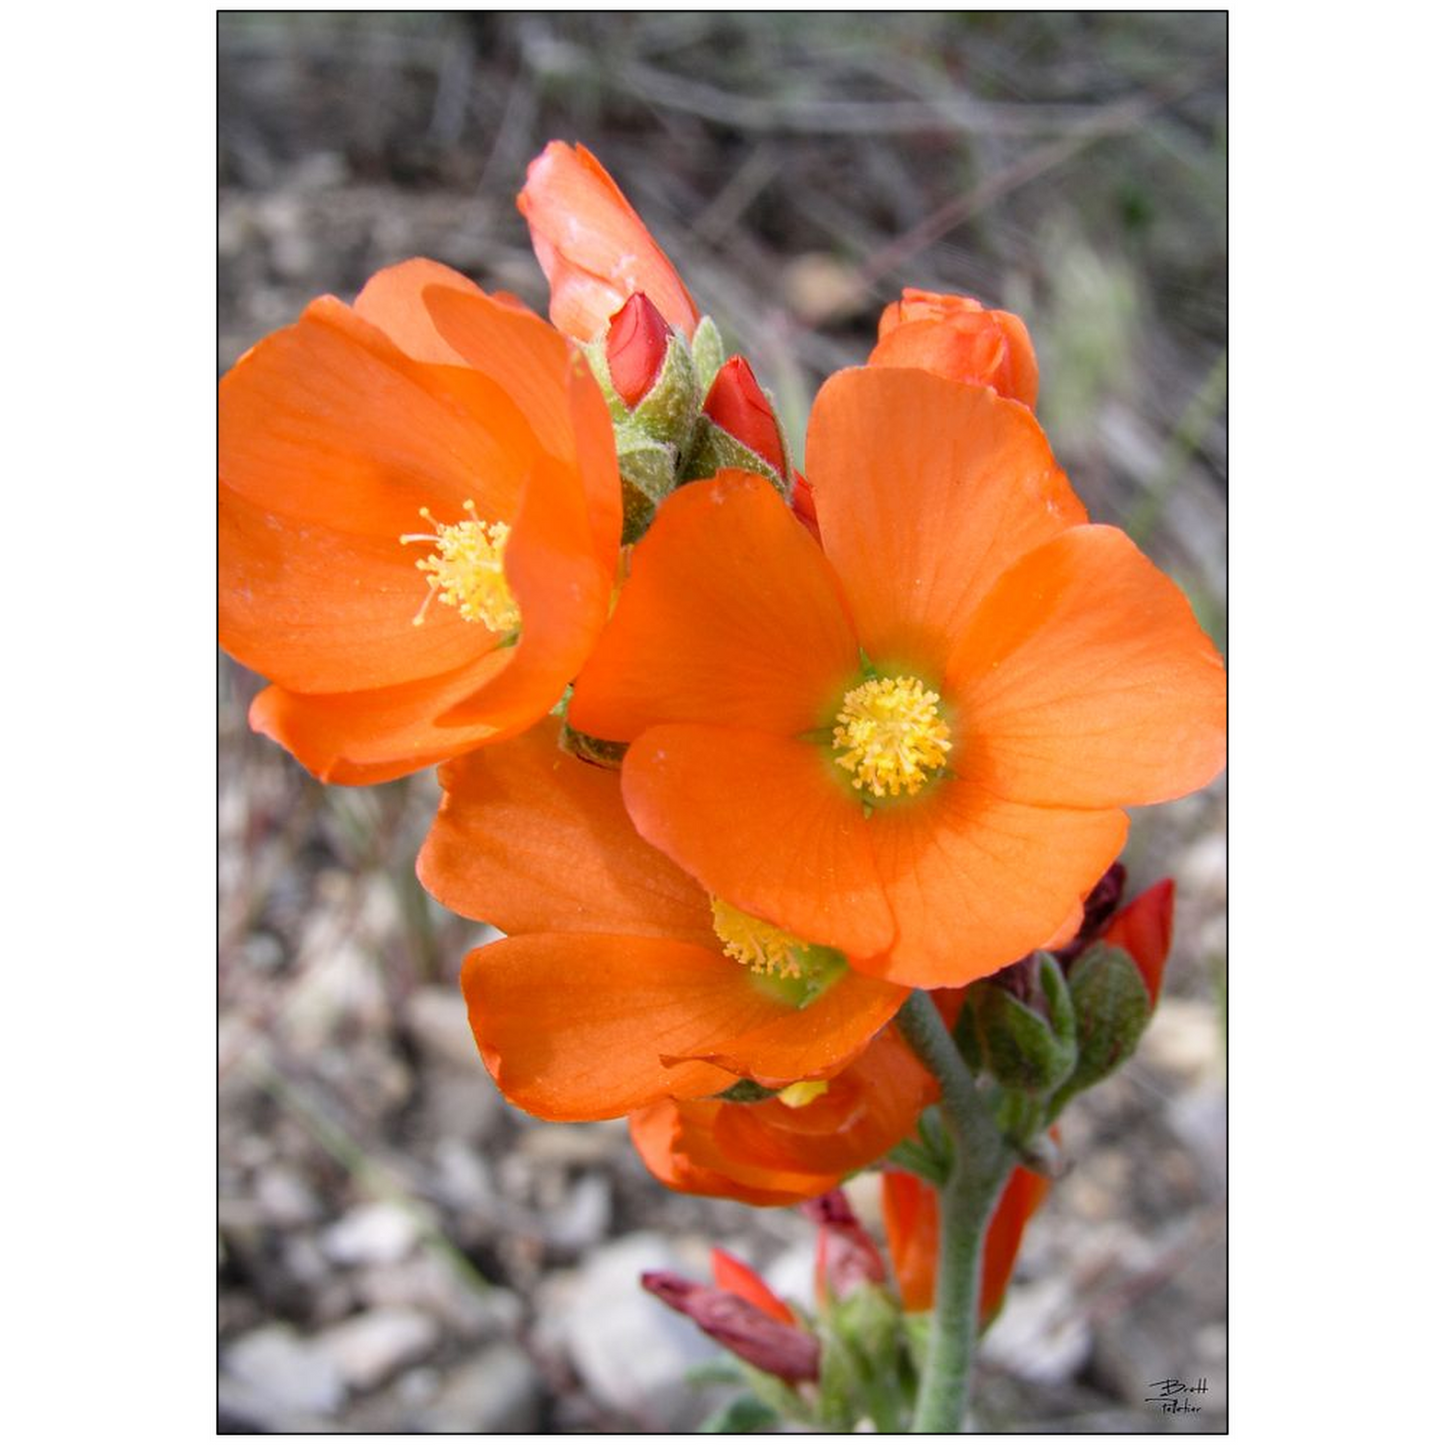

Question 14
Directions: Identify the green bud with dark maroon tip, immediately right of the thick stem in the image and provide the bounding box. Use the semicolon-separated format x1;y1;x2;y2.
955;954;1077;1094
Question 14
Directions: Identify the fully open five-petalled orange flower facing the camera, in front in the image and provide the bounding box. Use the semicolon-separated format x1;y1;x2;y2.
569;368;1224;988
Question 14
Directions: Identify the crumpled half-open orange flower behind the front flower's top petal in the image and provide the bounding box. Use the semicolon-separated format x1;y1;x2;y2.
868;288;1039;410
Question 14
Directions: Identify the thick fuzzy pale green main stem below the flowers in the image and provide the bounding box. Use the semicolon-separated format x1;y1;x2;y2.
897;990;1013;1435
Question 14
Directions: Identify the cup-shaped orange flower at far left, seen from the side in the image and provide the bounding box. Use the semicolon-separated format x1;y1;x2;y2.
220;262;621;783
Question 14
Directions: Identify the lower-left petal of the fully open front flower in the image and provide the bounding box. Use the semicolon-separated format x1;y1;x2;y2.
623;722;890;962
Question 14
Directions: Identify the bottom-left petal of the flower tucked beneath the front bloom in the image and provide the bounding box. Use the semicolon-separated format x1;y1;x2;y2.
461;933;745;1120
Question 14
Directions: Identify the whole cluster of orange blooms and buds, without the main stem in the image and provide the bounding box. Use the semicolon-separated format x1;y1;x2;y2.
220;142;1224;1433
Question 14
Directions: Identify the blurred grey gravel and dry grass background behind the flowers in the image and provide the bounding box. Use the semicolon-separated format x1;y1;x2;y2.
218;13;1227;1432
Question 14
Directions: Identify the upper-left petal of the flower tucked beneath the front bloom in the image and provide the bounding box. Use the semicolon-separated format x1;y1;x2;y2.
416;718;713;942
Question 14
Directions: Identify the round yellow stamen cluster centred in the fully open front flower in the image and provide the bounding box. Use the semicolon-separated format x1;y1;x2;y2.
832;678;954;798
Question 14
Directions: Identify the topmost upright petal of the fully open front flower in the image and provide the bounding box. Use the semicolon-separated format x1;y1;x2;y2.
808;367;1085;678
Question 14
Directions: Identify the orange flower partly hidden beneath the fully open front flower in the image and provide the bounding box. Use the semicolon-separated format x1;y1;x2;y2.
418;721;905;1120
